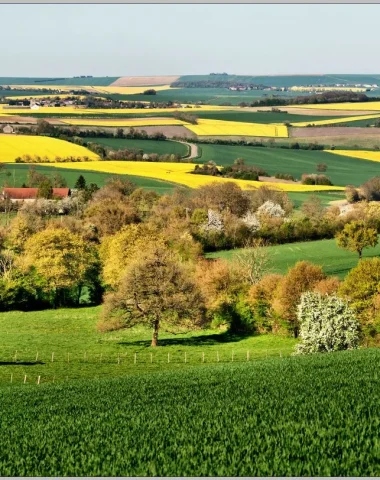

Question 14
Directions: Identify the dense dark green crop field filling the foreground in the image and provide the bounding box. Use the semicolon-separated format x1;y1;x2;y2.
0;349;380;477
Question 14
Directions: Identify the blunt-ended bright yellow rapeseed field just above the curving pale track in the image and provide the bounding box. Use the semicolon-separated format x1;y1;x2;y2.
186;118;288;138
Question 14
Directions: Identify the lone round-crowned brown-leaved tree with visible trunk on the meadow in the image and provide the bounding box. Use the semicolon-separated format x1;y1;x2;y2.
103;246;204;346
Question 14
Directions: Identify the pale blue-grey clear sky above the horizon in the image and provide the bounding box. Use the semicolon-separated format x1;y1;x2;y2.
0;4;380;77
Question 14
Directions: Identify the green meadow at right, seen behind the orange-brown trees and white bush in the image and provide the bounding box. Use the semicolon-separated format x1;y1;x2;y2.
207;239;380;279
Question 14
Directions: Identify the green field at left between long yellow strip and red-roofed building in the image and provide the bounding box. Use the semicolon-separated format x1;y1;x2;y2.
0;163;178;193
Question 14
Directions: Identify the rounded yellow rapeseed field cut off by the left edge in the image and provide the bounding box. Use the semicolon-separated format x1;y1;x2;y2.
0;135;99;163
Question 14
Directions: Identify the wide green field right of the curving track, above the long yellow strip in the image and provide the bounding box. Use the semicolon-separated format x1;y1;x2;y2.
200;144;379;186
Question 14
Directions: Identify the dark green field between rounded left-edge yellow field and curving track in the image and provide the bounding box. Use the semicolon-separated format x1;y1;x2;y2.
88;138;188;157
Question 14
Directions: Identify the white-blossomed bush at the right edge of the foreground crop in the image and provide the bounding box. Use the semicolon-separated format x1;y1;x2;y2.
295;292;359;354
